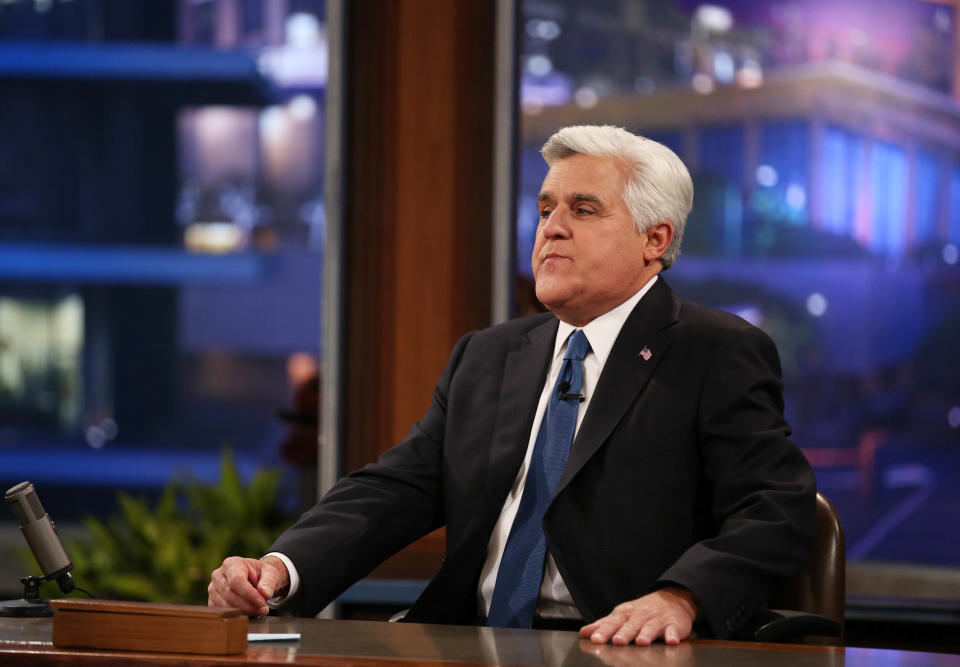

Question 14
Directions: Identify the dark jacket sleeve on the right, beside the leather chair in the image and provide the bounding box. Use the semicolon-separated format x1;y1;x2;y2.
654;327;816;637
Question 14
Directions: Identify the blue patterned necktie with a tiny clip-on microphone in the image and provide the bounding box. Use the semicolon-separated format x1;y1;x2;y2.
487;329;590;628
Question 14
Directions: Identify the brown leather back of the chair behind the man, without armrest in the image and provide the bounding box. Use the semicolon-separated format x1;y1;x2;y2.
770;493;846;644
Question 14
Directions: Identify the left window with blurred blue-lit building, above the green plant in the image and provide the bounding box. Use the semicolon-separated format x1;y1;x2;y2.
0;0;327;552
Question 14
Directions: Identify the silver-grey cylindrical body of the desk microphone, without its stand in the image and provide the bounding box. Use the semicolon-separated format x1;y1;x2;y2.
4;482;74;593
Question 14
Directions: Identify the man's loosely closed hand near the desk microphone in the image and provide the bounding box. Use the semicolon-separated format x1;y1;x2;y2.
207;556;290;616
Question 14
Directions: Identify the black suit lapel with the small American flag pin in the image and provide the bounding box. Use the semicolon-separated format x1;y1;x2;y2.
557;277;680;494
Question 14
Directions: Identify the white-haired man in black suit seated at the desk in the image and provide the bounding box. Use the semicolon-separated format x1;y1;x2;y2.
209;127;815;644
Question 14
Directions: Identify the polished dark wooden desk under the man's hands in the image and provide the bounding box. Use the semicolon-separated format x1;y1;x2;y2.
0;618;960;667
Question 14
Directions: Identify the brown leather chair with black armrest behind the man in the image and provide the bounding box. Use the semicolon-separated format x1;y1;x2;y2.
751;493;846;646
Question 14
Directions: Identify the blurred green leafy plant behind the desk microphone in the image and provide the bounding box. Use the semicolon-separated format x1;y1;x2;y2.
68;448;290;604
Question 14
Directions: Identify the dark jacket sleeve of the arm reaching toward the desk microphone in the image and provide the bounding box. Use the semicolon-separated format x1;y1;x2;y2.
269;334;472;616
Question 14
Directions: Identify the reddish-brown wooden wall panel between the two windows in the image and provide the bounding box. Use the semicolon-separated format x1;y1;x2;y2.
343;0;495;576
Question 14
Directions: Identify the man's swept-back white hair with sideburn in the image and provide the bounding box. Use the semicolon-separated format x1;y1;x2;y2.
540;125;693;269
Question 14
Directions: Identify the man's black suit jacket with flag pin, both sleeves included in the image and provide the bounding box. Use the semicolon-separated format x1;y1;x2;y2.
272;278;816;637
